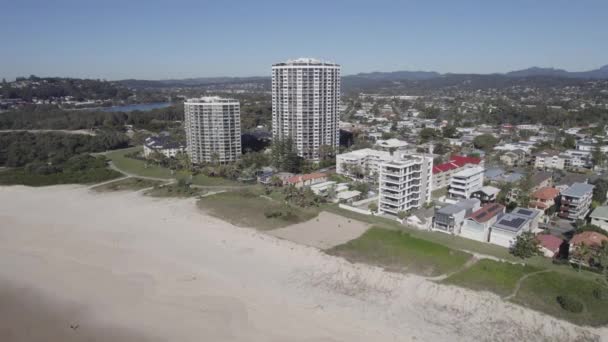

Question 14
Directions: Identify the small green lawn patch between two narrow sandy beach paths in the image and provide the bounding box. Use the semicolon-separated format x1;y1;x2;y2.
444;259;539;297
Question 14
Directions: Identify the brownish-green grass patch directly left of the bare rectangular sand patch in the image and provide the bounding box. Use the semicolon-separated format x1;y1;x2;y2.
198;189;319;230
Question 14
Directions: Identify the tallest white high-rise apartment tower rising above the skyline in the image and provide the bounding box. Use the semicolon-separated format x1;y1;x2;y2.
272;58;340;161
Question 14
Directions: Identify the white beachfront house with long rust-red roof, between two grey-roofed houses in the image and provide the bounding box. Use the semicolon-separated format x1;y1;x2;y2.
460;203;505;242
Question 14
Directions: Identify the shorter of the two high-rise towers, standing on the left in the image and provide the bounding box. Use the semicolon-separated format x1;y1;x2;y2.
184;96;241;164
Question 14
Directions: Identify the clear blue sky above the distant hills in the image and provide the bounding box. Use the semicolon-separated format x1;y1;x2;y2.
0;0;608;80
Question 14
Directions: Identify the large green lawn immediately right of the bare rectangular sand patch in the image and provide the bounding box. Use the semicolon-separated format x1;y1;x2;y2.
327;227;471;276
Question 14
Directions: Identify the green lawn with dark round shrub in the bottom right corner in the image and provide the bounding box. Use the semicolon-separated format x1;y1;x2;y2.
513;272;608;326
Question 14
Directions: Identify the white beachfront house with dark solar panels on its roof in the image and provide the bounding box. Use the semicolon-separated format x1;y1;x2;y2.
488;208;540;248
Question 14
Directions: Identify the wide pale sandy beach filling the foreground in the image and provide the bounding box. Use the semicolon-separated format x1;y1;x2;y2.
0;186;608;342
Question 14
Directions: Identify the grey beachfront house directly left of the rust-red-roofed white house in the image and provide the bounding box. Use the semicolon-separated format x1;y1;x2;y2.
433;198;481;235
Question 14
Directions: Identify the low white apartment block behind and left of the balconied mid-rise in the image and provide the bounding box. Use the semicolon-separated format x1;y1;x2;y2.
336;148;393;178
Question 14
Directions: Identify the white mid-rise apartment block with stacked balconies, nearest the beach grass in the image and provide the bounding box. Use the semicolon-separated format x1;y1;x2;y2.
378;154;433;215
